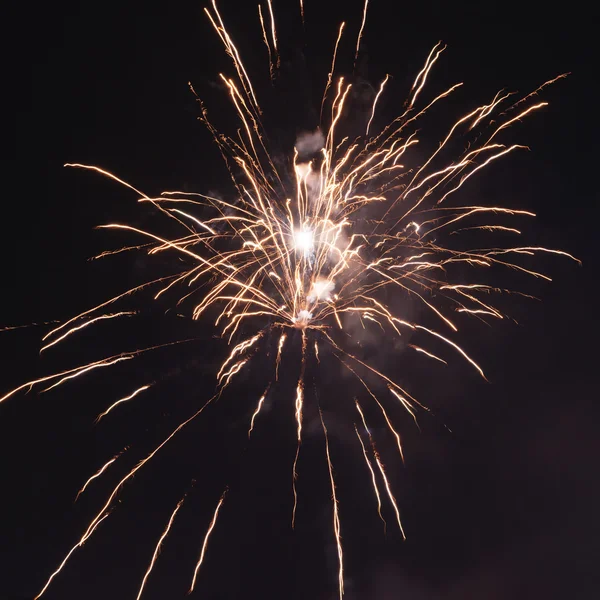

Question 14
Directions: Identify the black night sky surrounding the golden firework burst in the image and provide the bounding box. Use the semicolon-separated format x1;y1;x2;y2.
0;0;600;600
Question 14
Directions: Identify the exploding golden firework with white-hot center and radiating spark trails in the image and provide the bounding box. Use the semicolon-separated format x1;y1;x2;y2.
0;0;576;598
